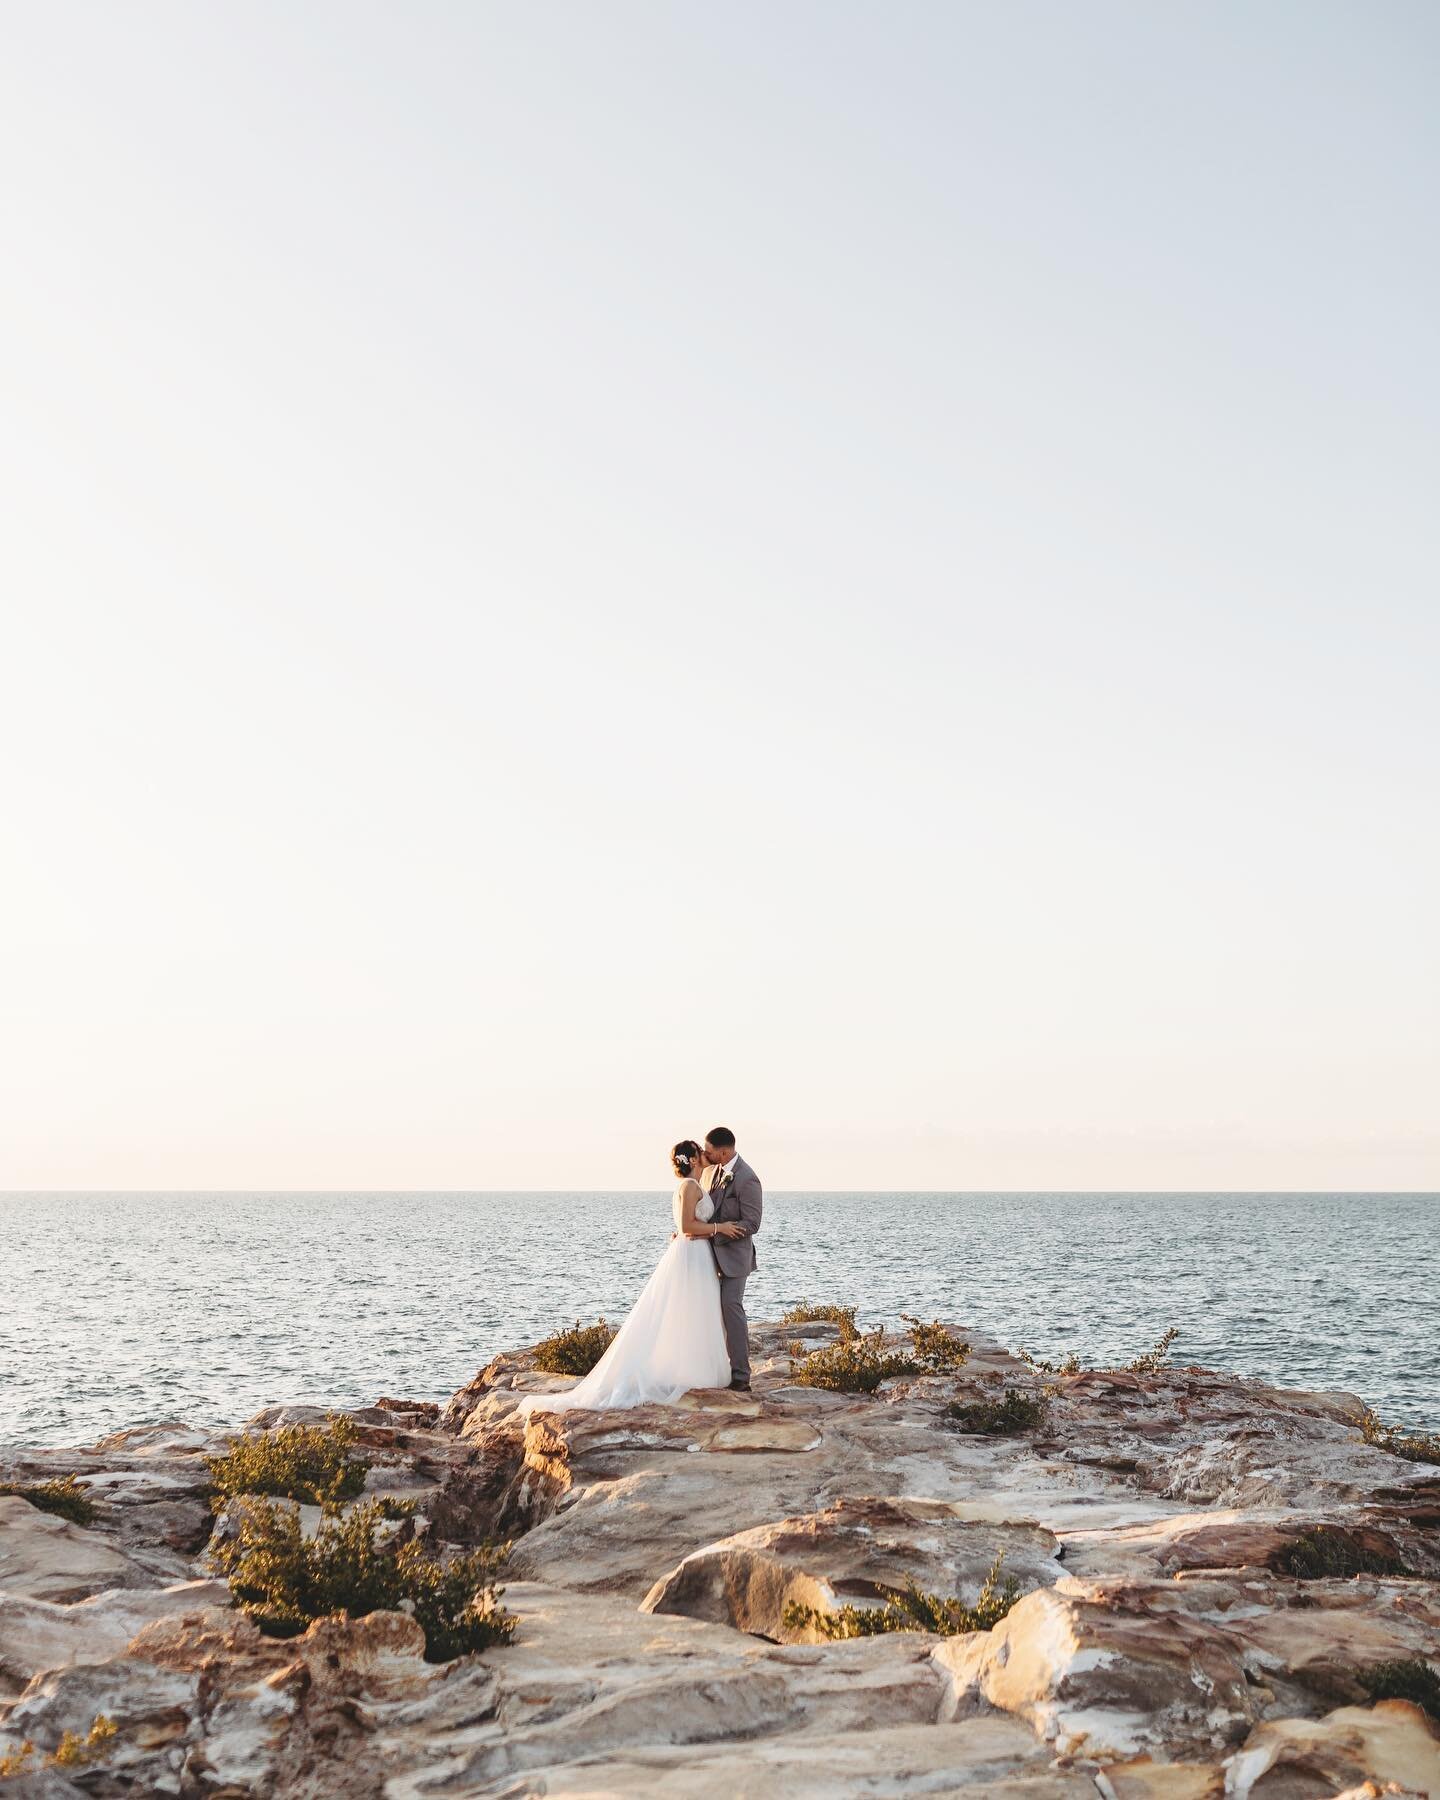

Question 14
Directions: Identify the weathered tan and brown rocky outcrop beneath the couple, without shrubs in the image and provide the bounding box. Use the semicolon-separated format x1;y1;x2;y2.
0;1325;1440;1800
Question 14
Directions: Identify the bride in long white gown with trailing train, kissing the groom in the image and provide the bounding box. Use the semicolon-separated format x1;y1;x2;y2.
518;1138;745;1413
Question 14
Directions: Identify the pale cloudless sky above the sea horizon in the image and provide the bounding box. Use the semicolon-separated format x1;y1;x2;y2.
0;0;1440;1190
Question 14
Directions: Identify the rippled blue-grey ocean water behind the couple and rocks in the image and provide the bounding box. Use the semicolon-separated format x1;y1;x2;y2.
0;1193;1440;1444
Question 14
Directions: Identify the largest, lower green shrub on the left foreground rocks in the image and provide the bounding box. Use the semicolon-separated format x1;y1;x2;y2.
212;1499;515;1663
